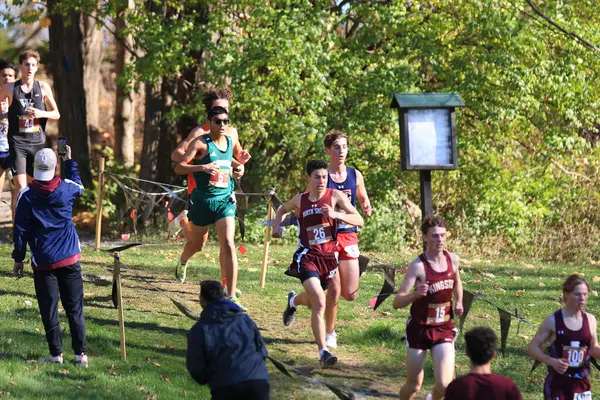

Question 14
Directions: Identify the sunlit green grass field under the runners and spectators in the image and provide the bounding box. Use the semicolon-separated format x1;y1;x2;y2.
0;242;600;400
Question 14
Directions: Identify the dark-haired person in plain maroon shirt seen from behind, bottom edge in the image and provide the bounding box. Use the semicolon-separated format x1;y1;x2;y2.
444;326;522;400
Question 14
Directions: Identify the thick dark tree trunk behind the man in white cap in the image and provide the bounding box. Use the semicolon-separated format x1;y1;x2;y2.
47;0;91;187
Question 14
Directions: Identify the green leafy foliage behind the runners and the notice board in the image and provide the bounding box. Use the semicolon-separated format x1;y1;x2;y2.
7;0;600;257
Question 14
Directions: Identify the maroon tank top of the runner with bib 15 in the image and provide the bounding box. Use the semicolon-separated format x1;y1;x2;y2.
408;251;456;326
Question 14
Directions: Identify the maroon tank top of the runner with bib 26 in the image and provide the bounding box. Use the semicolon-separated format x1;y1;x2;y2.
298;189;337;256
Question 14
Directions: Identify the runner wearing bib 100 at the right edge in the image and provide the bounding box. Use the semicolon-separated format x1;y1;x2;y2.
528;274;600;400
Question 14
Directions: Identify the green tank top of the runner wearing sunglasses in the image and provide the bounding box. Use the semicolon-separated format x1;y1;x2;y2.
194;135;233;200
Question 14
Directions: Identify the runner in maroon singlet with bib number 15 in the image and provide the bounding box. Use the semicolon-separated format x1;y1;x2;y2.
394;216;463;400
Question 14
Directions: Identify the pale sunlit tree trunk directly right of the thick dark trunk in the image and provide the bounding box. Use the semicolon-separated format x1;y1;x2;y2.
81;12;104;130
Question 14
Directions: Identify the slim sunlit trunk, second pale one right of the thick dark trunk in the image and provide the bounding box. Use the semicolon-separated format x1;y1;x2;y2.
114;0;135;167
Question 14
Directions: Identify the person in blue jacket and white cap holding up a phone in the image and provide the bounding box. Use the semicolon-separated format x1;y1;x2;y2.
12;146;88;367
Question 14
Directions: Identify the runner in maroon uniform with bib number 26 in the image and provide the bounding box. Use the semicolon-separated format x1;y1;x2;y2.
273;160;363;366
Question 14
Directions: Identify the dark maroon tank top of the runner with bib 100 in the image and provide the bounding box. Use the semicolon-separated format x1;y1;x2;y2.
548;310;592;379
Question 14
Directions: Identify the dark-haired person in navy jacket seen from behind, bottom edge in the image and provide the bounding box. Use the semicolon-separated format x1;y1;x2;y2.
186;281;269;400
